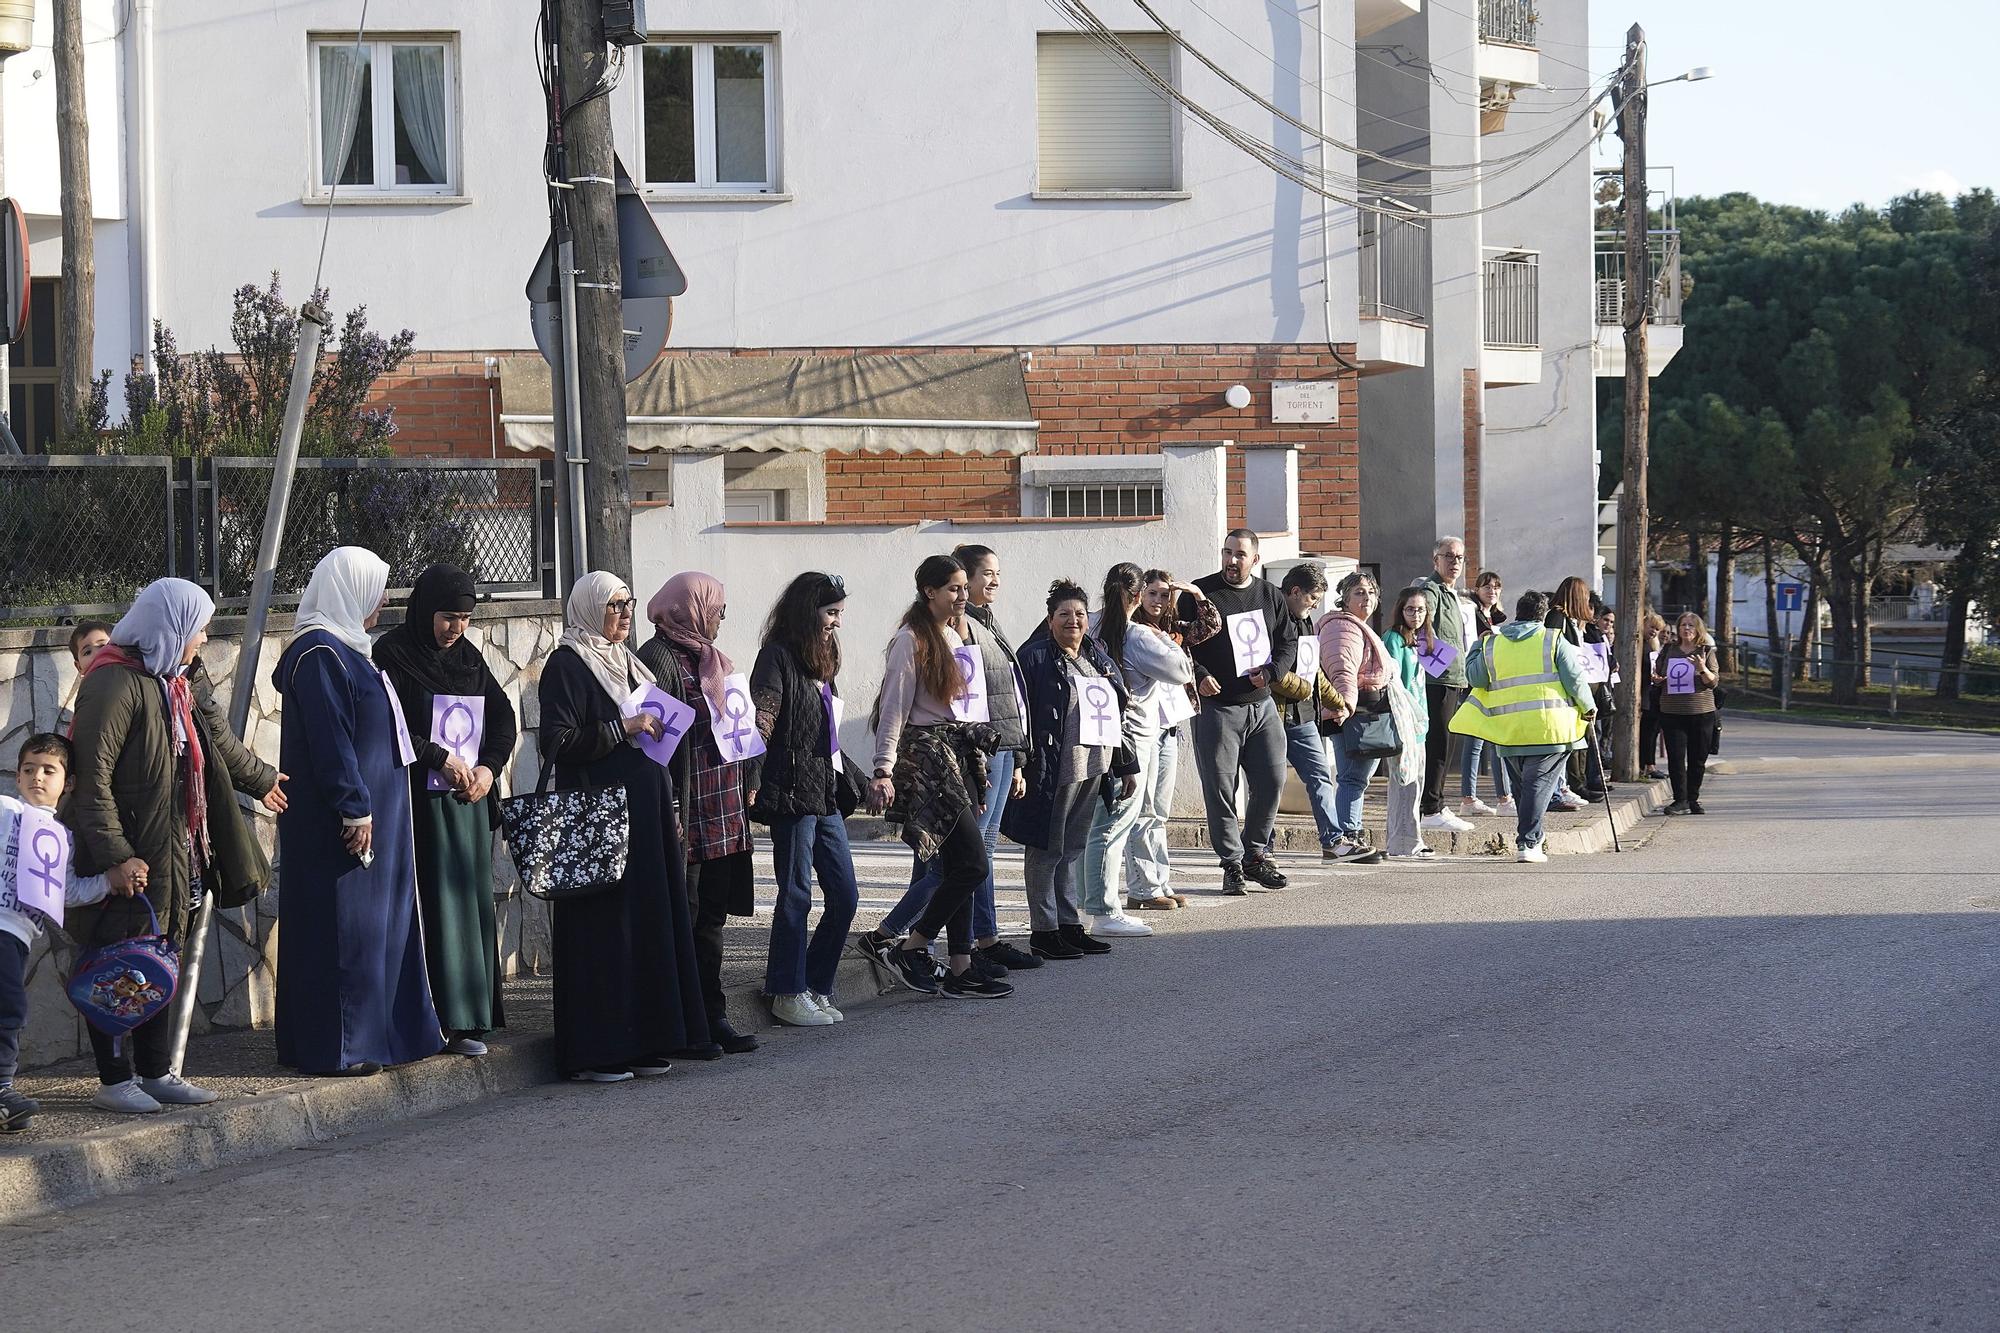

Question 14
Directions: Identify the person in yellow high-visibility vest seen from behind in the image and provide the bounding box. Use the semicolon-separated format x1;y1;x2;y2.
1452;592;1596;861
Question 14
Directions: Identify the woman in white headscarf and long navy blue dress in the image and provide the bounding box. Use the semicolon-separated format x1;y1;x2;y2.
272;546;444;1075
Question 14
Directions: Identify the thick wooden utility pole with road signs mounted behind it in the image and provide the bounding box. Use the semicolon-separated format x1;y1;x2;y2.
556;0;632;580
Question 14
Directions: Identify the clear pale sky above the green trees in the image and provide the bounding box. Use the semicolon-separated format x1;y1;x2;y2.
1584;0;2000;212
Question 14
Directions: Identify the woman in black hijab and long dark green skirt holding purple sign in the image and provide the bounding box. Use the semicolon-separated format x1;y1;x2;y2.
374;564;514;1055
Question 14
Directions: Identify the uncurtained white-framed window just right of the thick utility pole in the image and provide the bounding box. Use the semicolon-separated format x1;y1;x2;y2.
638;38;778;194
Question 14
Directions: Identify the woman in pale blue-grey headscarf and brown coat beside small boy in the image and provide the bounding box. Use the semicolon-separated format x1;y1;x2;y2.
64;578;286;1115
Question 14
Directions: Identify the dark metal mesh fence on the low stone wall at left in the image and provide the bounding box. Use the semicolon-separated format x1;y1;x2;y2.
0;456;556;620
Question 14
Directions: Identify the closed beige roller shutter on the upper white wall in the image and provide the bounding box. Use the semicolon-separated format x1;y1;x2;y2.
1036;32;1174;190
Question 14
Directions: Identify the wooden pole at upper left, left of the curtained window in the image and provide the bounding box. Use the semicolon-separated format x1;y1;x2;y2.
54;0;98;438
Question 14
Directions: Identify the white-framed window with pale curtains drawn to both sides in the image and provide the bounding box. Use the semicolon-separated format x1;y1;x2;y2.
312;36;460;194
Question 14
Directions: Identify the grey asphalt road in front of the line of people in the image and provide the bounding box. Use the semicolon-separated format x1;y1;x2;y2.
0;723;2000;1333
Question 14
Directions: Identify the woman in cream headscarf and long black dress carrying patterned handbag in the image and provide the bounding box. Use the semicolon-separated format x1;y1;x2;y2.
540;570;710;1083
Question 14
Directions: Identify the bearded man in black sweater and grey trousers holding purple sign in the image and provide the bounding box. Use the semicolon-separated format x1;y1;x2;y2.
1182;528;1298;895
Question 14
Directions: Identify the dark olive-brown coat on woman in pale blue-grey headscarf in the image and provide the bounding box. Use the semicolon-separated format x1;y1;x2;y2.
62;660;278;949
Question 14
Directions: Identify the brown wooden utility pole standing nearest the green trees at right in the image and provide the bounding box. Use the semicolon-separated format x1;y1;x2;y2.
1612;24;1652;783
